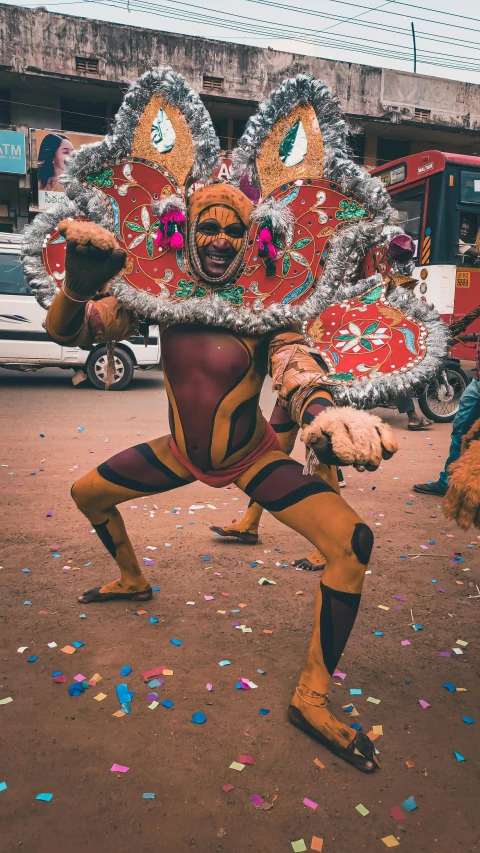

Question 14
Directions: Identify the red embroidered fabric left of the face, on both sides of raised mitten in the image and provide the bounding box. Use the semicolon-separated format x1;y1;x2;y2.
43;160;186;296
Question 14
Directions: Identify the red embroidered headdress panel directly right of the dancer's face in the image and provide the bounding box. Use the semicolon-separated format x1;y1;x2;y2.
237;180;372;311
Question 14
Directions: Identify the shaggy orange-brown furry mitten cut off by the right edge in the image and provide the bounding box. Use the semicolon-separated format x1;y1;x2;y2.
443;436;480;530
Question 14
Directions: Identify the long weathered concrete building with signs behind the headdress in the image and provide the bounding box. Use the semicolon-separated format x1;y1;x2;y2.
0;4;480;231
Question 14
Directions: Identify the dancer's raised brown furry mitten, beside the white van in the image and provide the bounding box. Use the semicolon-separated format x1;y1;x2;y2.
57;219;127;298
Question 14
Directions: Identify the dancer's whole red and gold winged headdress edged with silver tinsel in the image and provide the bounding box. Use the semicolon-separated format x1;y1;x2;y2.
23;68;447;406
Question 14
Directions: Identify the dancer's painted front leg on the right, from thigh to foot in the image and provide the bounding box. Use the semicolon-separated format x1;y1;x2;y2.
237;452;375;772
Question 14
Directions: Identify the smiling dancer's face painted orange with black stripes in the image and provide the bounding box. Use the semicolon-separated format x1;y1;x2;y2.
195;204;245;278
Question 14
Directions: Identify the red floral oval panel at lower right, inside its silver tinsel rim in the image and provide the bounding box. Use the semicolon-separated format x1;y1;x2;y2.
307;284;427;384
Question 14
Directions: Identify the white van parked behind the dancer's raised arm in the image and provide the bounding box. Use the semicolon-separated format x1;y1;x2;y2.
0;234;160;391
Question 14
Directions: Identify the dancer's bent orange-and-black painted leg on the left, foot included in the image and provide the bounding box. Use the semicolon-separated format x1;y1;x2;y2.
72;436;194;604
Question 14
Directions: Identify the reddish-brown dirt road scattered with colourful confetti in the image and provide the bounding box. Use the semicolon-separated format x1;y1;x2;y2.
0;372;480;853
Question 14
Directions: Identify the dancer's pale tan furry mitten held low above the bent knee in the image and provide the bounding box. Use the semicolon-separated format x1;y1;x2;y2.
302;407;398;471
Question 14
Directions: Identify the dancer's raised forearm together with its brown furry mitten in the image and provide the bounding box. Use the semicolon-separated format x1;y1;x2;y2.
46;219;136;346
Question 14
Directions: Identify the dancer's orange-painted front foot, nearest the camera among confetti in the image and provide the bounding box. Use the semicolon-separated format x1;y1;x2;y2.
288;687;380;773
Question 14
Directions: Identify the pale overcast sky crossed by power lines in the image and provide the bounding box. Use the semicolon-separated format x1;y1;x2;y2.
5;0;480;84
